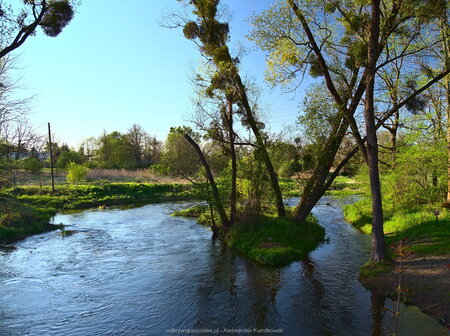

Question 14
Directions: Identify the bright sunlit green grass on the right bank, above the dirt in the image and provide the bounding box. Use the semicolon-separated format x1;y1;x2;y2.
344;200;450;255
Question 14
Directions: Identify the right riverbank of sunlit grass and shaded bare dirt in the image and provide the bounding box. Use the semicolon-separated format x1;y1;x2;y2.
344;199;450;327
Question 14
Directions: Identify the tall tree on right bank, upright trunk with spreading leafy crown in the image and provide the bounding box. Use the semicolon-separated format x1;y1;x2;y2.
250;0;449;261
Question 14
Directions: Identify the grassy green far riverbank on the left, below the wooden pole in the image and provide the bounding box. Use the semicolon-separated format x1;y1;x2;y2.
0;183;193;244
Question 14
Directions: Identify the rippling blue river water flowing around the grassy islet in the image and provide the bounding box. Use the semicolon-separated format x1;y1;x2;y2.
0;198;448;336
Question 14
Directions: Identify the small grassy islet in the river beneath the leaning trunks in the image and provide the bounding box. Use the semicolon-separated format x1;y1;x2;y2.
174;206;325;267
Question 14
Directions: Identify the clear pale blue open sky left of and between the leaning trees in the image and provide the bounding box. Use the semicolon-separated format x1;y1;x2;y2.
12;0;302;147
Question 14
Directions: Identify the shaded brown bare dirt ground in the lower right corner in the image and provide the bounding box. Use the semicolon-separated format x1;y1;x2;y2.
363;254;450;329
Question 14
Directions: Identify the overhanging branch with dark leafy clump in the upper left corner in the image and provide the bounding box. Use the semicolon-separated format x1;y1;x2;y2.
0;0;74;59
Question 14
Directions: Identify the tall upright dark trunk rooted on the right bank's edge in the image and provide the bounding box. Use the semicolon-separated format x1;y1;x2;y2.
364;0;386;262
